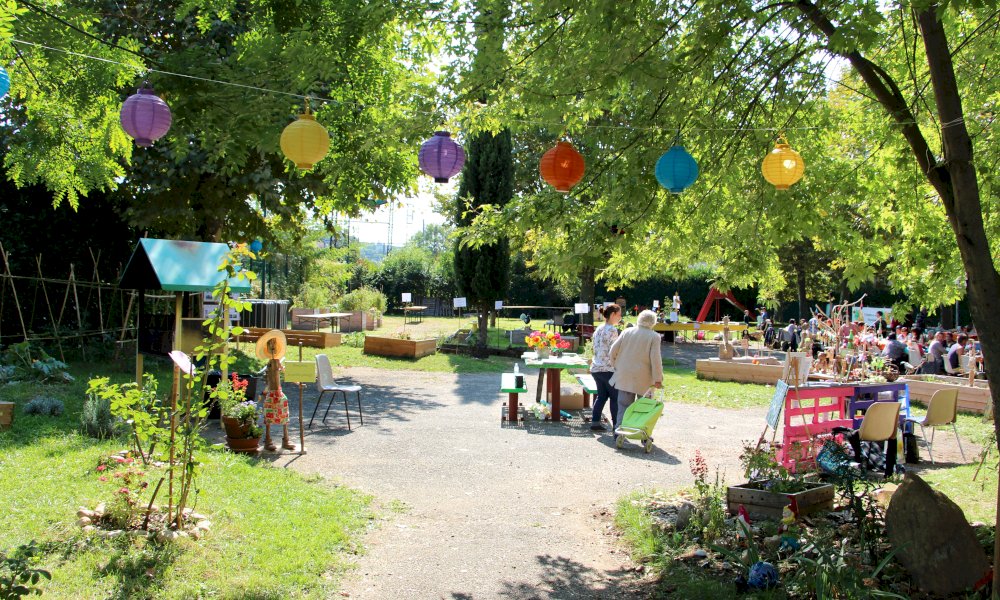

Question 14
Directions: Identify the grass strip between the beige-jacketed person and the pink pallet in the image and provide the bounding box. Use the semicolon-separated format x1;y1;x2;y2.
663;367;774;410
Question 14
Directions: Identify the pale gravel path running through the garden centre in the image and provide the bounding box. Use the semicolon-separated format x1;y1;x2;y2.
266;368;766;599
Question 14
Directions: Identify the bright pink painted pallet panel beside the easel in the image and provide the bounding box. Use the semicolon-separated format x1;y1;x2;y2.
777;386;854;473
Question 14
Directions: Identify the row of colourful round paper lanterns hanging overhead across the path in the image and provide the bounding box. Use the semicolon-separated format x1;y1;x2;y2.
0;67;805;194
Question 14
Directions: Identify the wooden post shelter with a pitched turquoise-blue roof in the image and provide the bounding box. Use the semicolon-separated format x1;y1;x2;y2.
118;238;250;389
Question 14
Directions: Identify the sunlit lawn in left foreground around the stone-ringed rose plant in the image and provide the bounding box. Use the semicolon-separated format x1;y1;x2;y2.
0;361;374;598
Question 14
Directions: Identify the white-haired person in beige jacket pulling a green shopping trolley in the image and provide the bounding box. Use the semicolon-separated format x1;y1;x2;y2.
611;310;663;425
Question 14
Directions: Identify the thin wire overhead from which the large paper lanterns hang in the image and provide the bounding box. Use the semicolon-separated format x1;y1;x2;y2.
3;38;980;132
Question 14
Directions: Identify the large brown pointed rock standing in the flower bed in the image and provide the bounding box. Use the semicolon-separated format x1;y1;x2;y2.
885;473;990;597
